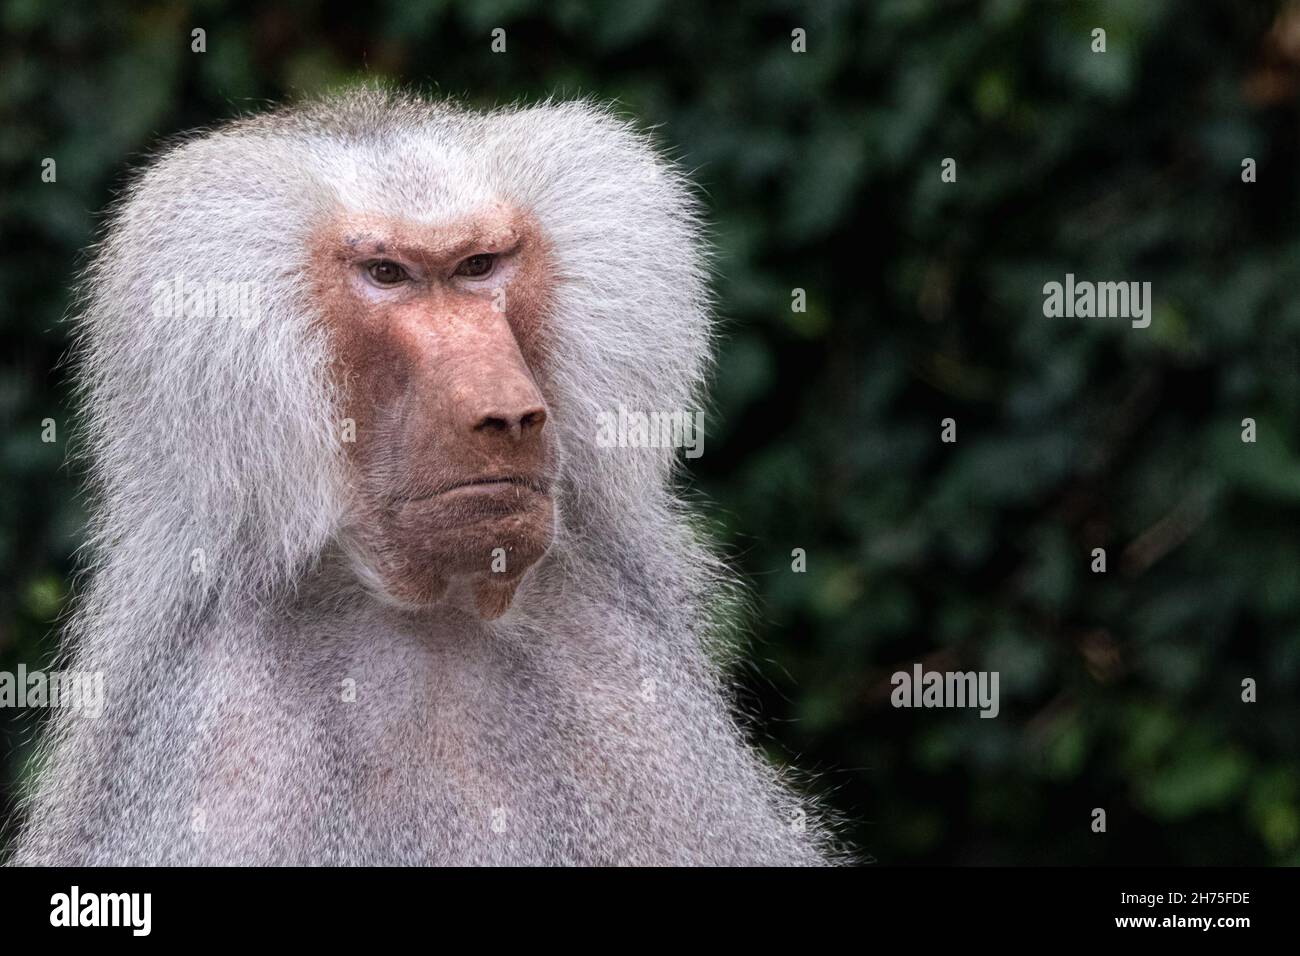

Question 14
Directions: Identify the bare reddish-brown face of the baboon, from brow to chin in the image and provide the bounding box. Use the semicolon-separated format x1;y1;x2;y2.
312;204;556;618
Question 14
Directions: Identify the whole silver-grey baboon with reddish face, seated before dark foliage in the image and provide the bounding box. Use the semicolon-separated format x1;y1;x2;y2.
14;88;842;865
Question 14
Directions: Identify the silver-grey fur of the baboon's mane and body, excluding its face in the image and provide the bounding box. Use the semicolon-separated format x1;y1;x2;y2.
14;90;833;865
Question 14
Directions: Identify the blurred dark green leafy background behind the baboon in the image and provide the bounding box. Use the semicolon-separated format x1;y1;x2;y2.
0;0;1300;864
